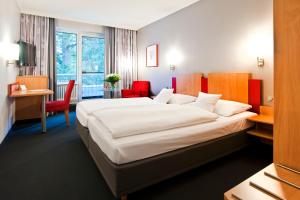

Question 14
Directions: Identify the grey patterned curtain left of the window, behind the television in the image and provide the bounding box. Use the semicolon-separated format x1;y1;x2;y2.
19;14;56;100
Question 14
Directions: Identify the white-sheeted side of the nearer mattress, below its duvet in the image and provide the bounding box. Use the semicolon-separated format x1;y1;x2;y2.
88;112;256;164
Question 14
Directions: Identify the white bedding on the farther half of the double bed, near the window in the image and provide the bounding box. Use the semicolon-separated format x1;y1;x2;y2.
76;97;157;127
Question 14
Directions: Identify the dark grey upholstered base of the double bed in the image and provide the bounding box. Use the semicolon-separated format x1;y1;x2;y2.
77;120;249;199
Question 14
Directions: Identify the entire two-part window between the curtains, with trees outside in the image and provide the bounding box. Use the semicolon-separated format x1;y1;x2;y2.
56;31;105;101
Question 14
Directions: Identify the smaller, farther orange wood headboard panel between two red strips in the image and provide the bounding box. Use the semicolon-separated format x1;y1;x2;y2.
176;73;202;96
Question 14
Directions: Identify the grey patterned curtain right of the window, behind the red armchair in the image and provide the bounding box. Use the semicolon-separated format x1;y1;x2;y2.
105;27;137;88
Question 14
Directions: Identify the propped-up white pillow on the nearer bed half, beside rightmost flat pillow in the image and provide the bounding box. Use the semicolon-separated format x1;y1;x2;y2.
194;92;222;112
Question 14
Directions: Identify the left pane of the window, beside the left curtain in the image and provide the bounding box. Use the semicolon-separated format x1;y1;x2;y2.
56;32;77;84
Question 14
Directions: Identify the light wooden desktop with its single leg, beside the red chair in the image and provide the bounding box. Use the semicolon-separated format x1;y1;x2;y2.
9;89;53;133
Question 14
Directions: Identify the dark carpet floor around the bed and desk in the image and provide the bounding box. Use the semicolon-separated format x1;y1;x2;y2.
0;112;272;200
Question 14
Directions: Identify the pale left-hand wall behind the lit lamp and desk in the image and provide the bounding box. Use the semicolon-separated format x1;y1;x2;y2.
0;0;20;143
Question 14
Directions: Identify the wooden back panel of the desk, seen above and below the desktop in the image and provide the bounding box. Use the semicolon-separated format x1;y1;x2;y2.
16;76;48;120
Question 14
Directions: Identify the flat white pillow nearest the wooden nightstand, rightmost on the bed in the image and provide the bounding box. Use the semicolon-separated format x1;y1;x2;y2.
215;100;252;117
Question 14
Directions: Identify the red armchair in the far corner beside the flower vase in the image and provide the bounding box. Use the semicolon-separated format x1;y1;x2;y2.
121;81;150;98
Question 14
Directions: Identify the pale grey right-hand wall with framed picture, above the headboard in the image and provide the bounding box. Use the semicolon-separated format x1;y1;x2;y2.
138;0;273;104
